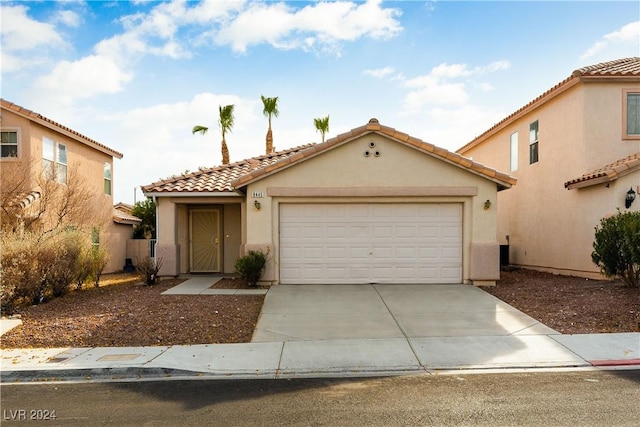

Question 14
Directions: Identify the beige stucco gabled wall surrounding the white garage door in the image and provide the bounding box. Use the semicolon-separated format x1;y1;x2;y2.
246;134;499;282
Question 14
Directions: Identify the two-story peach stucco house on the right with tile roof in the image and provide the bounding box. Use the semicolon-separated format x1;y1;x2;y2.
457;57;640;278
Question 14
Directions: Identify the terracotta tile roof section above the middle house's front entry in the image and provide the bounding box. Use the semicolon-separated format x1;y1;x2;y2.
142;144;313;194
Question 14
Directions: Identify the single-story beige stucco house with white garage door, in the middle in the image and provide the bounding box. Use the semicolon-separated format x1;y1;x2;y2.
143;119;516;285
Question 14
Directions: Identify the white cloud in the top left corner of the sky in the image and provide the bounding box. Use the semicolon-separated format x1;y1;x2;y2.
0;5;65;52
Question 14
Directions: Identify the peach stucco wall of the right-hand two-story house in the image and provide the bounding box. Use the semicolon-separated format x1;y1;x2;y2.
461;83;640;277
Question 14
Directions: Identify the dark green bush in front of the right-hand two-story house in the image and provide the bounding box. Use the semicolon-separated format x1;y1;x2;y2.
591;212;640;287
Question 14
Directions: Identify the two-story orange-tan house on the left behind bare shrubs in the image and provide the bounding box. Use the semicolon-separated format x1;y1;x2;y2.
0;99;132;272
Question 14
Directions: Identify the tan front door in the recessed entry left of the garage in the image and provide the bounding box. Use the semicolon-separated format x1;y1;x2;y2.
189;209;222;273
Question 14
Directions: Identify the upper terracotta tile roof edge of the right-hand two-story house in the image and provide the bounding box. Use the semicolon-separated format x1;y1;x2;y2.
456;57;640;154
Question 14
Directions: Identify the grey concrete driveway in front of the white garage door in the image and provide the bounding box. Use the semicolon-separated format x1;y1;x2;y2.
252;285;558;342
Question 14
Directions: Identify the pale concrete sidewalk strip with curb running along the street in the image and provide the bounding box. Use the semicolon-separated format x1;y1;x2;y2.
2;333;640;383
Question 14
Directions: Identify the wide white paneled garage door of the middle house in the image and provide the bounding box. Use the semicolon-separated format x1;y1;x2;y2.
280;203;462;284
